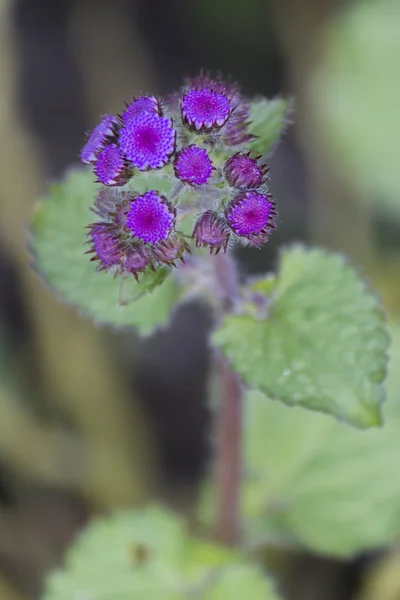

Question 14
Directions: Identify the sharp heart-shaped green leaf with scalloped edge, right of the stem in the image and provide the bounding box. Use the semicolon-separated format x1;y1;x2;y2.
214;246;388;428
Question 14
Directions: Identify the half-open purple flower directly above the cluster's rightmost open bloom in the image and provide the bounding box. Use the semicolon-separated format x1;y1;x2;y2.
224;152;269;188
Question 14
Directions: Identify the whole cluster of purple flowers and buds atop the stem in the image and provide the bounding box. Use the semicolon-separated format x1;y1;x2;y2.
81;72;277;278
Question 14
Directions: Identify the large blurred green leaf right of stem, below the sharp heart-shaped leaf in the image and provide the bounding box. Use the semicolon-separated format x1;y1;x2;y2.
243;326;400;557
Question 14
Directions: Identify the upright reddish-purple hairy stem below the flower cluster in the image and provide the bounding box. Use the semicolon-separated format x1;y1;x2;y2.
213;254;243;546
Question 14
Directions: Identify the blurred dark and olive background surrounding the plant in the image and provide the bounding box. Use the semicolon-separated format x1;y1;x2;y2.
0;0;400;600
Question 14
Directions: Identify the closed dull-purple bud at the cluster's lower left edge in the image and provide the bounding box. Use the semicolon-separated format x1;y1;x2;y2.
88;223;123;271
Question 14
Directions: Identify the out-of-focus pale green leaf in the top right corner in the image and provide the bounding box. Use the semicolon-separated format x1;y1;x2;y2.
309;0;400;217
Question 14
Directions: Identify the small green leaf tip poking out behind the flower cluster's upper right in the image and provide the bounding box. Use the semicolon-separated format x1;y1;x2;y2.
249;98;290;154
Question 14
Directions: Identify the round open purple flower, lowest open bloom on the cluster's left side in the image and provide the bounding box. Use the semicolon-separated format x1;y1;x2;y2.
126;190;176;244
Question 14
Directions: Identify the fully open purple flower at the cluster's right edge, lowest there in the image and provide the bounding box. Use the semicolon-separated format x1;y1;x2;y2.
225;190;276;247
